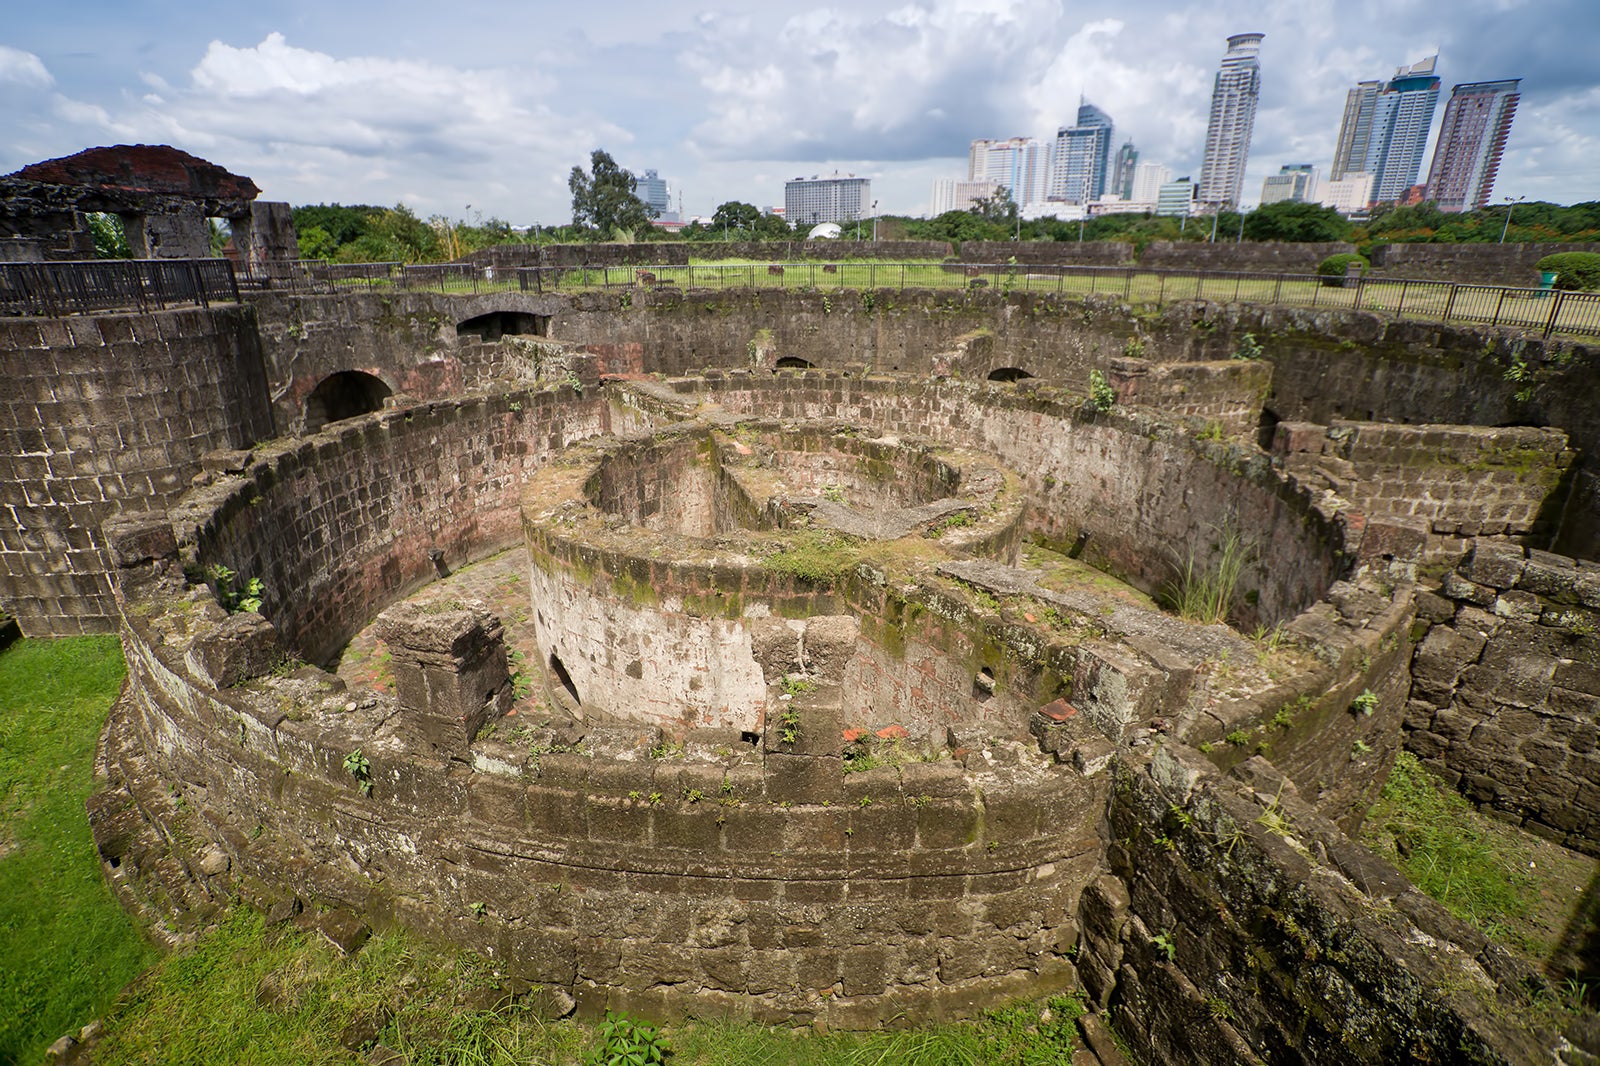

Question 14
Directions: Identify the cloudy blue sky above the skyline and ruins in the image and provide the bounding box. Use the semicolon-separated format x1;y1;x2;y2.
0;0;1600;226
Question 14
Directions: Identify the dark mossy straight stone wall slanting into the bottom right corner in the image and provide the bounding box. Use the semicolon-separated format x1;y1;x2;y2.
1078;746;1557;1066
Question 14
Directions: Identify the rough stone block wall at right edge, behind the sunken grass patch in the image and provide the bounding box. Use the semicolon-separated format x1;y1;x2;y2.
1405;541;1600;855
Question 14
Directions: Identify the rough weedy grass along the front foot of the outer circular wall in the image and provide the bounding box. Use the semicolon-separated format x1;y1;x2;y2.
96;908;1083;1066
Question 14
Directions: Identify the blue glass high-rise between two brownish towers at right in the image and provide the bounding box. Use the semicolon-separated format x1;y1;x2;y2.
1422;78;1522;211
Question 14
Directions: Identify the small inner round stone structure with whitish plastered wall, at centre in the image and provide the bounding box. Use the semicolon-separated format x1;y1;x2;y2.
523;421;1022;735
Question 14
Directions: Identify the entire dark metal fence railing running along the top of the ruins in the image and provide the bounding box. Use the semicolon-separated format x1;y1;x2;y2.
0;259;1600;336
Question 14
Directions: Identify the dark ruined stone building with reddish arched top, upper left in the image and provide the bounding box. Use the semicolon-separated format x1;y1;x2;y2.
0;144;299;271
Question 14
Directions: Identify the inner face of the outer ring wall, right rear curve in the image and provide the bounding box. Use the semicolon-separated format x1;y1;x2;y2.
672;370;1342;624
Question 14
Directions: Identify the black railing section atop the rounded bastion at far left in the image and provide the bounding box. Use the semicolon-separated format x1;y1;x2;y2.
0;259;238;317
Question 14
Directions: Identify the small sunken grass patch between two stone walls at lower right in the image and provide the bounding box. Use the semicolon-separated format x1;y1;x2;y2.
1362;752;1549;956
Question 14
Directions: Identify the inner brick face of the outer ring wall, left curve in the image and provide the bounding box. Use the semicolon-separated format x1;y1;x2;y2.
171;387;627;663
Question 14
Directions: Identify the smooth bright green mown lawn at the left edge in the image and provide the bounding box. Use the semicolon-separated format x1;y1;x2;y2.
0;637;157;1063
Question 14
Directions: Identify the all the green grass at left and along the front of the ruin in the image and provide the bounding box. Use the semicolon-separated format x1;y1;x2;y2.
0;637;1083;1066
